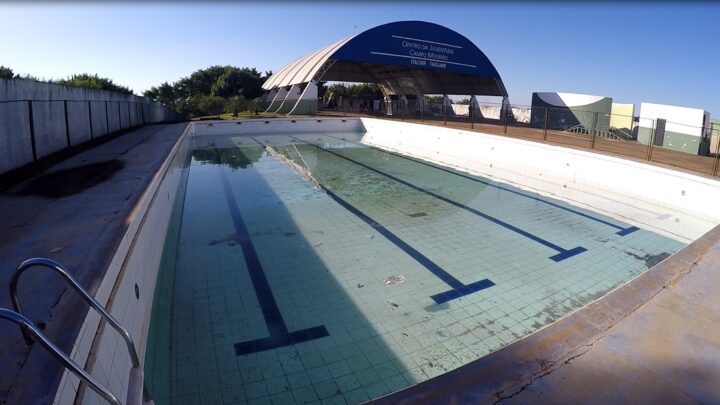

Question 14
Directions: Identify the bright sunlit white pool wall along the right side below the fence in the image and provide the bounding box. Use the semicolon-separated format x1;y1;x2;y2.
362;118;720;242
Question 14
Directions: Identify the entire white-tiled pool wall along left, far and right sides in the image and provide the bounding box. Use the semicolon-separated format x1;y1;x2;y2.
47;117;720;404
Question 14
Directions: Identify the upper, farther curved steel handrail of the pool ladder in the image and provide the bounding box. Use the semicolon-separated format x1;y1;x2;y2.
10;257;140;367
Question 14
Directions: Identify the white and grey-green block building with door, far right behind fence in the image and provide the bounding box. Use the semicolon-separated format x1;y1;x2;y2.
637;103;711;155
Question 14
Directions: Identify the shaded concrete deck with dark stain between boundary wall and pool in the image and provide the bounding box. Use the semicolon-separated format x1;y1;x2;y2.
0;123;186;403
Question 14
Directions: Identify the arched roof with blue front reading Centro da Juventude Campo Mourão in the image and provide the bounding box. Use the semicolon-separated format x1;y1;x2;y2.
263;21;507;97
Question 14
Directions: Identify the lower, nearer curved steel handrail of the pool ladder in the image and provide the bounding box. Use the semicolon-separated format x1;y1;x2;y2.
0;308;121;405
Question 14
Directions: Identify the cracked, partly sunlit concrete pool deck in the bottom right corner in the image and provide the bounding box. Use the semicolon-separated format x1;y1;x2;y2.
376;226;720;404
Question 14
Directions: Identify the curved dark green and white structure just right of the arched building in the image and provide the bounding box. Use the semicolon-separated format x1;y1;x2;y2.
530;92;613;132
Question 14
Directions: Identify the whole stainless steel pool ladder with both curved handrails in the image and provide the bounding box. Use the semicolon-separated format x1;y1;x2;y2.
0;258;149;405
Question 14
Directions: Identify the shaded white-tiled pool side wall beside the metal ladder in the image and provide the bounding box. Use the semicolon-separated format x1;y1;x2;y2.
53;125;192;404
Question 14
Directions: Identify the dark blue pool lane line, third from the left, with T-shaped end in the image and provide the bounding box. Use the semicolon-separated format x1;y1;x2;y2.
288;135;587;262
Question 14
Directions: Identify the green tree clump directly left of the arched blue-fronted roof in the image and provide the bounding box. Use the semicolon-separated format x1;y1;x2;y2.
143;66;272;116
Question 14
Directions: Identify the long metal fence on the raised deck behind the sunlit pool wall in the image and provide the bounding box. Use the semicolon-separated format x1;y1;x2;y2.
318;100;720;176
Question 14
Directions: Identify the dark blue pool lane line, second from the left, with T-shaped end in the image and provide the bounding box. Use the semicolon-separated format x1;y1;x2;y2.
252;138;495;304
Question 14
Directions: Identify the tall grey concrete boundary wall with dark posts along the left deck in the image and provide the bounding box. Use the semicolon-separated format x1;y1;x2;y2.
0;79;180;174
